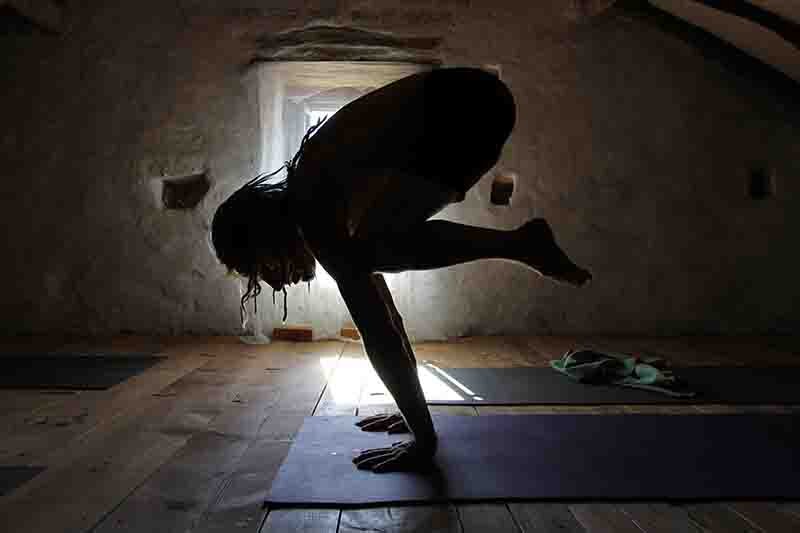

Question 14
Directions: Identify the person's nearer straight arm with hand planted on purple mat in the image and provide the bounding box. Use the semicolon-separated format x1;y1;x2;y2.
334;273;436;472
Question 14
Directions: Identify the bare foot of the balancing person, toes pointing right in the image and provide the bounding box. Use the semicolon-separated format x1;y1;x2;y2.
517;218;592;287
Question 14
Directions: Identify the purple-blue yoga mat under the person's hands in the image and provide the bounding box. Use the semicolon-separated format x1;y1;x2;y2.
267;414;800;507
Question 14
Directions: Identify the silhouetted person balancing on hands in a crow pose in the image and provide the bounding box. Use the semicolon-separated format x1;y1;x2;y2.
212;68;591;472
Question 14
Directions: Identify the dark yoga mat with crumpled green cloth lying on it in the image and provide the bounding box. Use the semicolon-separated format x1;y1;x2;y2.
425;365;800;405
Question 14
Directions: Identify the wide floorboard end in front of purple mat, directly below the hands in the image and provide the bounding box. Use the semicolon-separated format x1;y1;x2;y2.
339;505;462;533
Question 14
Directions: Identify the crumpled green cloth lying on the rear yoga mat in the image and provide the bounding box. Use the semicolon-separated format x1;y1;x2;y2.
550;350;695;398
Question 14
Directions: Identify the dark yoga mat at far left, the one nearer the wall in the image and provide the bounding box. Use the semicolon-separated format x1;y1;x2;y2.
0;354;165;390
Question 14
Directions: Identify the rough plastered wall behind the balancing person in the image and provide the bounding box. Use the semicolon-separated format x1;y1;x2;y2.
0;0;800;339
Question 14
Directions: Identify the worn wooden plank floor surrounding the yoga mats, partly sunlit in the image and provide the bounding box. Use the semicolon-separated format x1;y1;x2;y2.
0;337;800;533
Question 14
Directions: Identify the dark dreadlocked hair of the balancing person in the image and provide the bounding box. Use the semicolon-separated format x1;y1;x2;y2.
211;117;328;322
